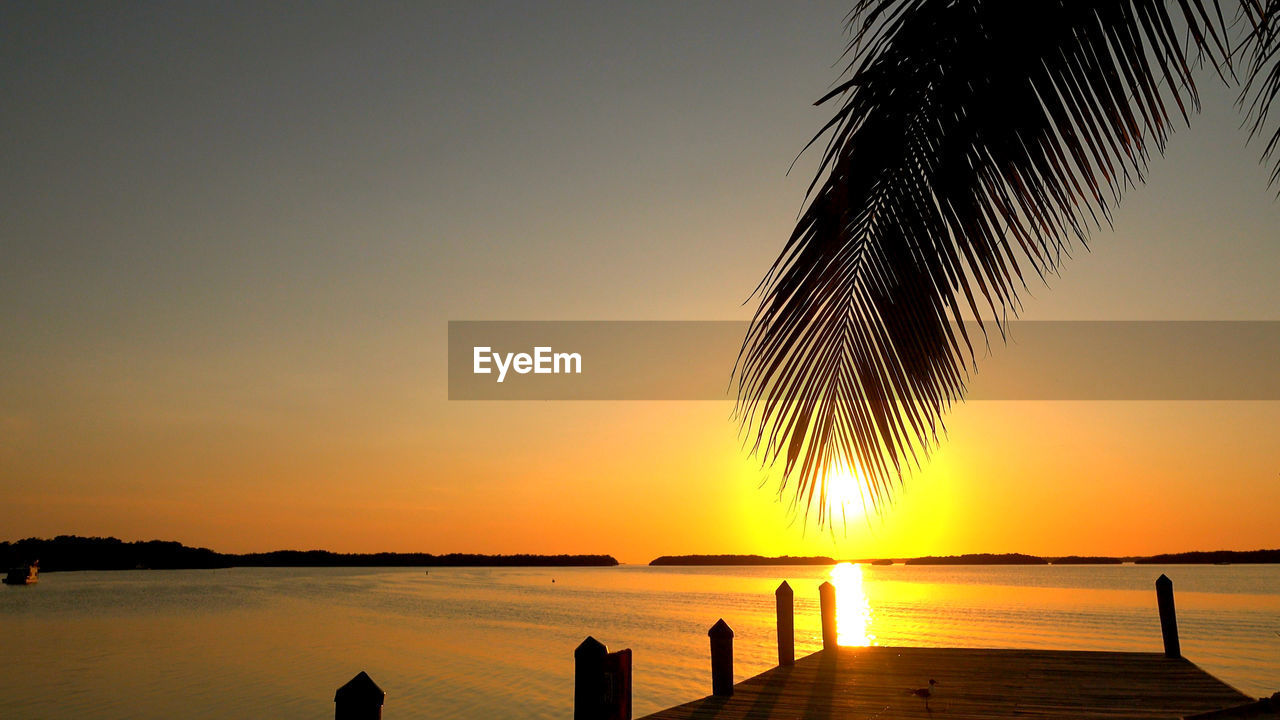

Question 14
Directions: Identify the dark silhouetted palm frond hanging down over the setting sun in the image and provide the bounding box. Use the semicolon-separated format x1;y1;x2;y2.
735;0;1280;525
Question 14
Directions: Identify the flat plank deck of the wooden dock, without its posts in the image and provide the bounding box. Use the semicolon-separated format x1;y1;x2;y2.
637;647;1252;720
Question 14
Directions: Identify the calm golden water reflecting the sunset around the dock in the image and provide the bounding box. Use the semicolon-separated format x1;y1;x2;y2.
0;565;1280;720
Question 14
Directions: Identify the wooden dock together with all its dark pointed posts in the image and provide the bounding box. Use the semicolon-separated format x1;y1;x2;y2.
334;575;1280;720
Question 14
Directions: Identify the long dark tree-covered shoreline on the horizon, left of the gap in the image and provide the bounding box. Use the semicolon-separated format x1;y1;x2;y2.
0;536;618;573
